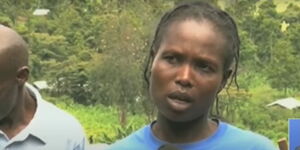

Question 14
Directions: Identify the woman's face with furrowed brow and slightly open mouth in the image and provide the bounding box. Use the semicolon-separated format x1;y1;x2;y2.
150;20;226;122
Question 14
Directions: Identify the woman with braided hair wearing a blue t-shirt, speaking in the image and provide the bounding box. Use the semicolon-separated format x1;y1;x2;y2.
109;2;276;150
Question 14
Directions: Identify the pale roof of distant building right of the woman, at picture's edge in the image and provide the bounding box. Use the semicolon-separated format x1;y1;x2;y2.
267;97;300;110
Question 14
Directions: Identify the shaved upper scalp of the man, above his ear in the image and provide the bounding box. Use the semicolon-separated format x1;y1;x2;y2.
0;25;28;74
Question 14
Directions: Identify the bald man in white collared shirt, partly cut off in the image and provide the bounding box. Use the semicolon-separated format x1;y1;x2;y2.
0;25;86;150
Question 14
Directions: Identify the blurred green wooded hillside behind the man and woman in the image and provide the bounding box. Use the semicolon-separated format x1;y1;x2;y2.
0;0;300;144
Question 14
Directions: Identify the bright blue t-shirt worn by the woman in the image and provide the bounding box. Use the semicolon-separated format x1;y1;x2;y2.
108;122;277;150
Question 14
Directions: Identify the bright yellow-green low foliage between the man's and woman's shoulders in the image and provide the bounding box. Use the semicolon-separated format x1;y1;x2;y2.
45;96;147;143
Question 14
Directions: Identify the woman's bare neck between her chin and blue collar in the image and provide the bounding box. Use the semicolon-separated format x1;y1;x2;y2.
152;114;218;144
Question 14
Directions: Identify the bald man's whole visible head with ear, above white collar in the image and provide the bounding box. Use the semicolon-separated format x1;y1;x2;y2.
0;25;29;120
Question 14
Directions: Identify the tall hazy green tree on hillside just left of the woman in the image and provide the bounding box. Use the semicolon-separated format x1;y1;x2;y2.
89;1;152;125
